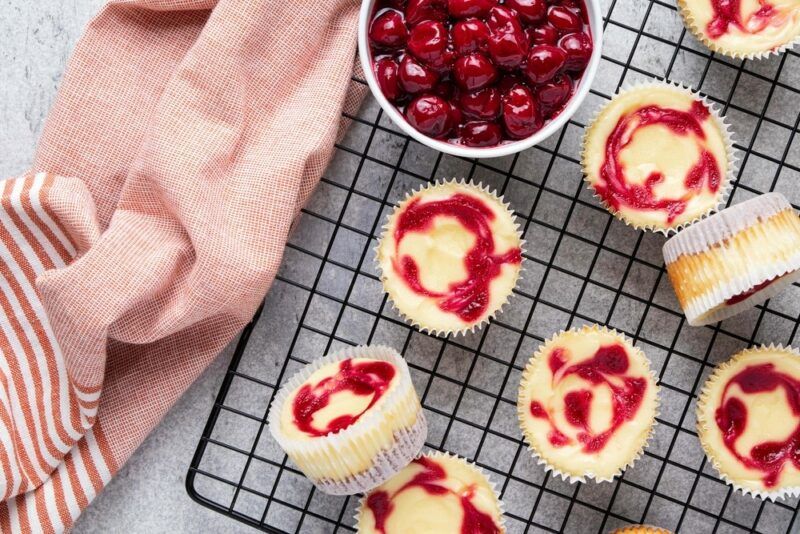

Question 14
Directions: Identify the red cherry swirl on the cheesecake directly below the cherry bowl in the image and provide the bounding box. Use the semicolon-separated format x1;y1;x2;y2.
392;193;522;323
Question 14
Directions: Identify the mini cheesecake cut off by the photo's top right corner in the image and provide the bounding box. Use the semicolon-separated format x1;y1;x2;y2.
678;0;800;58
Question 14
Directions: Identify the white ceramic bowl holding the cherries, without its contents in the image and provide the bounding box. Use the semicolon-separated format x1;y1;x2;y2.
358;0;603;158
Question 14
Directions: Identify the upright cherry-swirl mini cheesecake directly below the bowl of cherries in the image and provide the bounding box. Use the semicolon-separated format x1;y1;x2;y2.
377;182;522;334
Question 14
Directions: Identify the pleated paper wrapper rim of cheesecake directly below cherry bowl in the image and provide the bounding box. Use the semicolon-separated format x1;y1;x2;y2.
375;179;525;337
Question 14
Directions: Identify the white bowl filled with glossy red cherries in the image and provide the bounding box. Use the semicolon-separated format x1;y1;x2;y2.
358;0;602;158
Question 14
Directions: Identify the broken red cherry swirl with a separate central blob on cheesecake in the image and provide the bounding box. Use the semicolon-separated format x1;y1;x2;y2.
530;344;647;454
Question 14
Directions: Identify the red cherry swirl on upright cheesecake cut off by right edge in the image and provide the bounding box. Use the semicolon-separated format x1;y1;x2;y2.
715;363;800;488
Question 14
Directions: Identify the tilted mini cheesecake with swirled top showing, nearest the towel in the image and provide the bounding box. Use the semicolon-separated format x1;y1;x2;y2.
269;347;427;495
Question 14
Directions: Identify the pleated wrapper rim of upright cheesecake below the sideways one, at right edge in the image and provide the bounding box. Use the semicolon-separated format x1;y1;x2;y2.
697;343;800;501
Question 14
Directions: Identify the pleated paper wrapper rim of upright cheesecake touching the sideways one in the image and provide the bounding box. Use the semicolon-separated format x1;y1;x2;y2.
581;81;738;236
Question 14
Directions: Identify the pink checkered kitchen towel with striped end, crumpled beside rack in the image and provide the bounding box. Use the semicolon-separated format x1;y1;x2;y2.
0;0;363;532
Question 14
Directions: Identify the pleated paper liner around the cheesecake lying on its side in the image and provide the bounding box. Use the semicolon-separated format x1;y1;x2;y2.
664;193;800;326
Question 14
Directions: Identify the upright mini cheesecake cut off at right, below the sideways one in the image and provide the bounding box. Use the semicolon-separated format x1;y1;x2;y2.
697;346;800;499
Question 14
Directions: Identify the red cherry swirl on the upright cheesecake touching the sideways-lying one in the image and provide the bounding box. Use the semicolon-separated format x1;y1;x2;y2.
594;101;722;223
